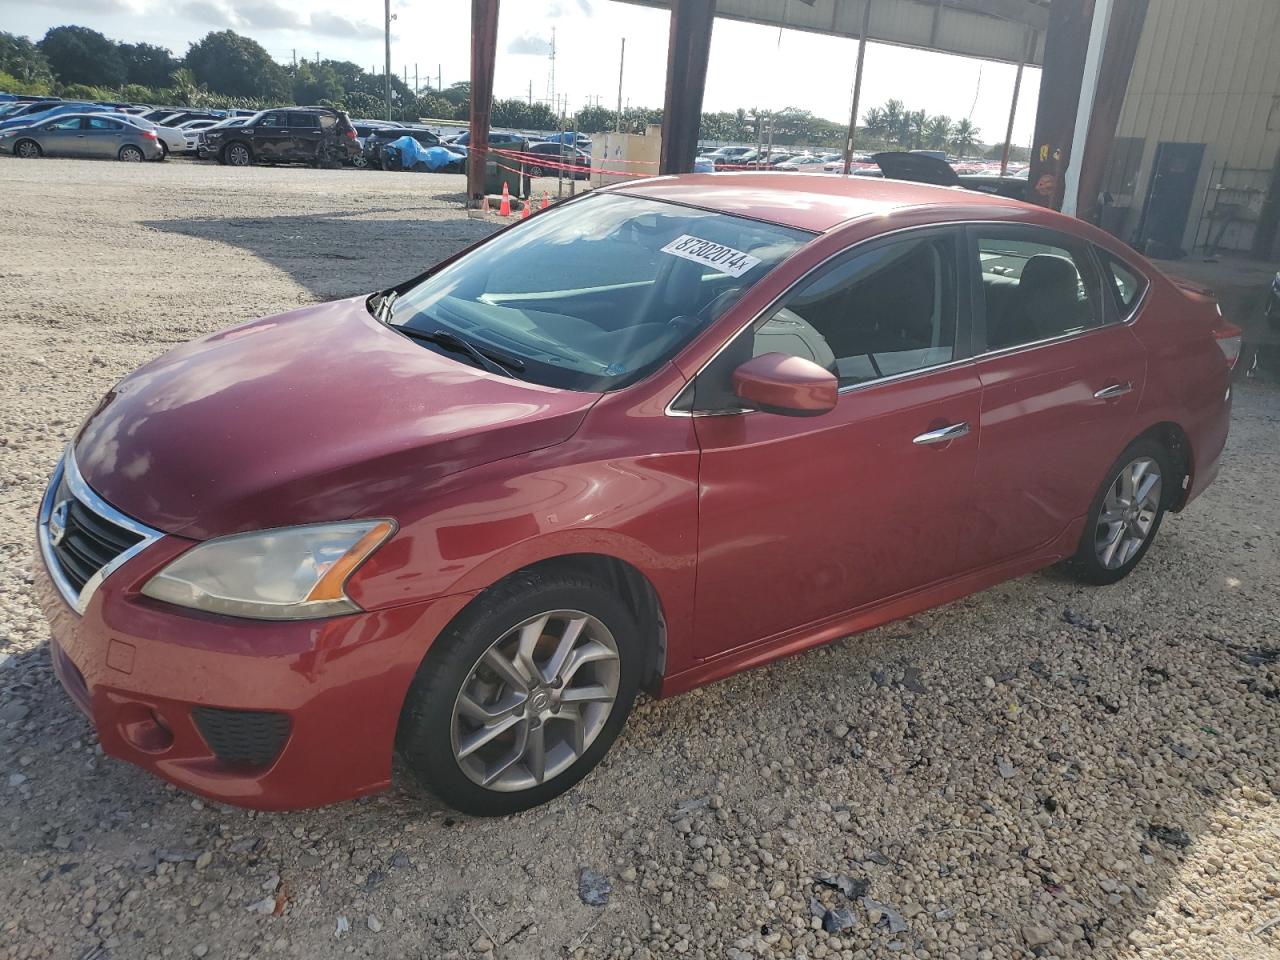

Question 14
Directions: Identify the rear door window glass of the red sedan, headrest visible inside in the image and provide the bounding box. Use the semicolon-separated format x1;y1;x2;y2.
978;230;1106;349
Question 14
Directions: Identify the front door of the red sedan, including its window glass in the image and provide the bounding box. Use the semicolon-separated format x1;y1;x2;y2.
691;229;980;658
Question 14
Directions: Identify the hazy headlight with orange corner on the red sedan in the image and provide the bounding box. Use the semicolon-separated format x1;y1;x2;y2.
142;520;396;620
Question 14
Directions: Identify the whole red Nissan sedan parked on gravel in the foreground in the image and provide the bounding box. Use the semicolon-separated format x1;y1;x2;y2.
37;174;1239;814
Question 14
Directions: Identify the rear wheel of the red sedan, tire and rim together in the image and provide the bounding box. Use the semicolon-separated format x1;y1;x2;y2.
1065;439;1180;586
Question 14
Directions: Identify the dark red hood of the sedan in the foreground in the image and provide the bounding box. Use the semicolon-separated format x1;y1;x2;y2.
76;298;599;540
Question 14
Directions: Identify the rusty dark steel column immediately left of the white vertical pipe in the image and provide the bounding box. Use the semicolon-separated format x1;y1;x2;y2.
1027;0;1093;210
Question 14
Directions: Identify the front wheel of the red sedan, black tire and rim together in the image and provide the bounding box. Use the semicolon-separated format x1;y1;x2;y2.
396;571;644;817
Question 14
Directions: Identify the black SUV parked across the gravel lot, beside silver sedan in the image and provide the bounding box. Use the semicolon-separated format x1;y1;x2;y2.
205;106;360;166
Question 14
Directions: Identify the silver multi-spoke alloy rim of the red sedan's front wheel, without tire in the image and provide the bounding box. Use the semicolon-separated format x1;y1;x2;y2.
451;611;620;792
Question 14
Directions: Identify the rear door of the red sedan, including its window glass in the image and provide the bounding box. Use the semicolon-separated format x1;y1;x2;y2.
960;225;1147;567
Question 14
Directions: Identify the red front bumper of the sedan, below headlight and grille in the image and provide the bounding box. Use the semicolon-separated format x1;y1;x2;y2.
35;529;468;810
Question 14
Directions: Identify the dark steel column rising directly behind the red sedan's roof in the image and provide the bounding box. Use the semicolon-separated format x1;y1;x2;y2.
658;0;716;174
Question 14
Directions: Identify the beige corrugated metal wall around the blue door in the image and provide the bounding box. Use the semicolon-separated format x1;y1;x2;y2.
1115;0;1280;251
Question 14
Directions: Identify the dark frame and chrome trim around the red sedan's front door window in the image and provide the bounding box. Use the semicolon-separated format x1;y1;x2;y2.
663;221;977;417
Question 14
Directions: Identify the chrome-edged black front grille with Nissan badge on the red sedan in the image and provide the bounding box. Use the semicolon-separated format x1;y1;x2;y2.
38;451;161;613
